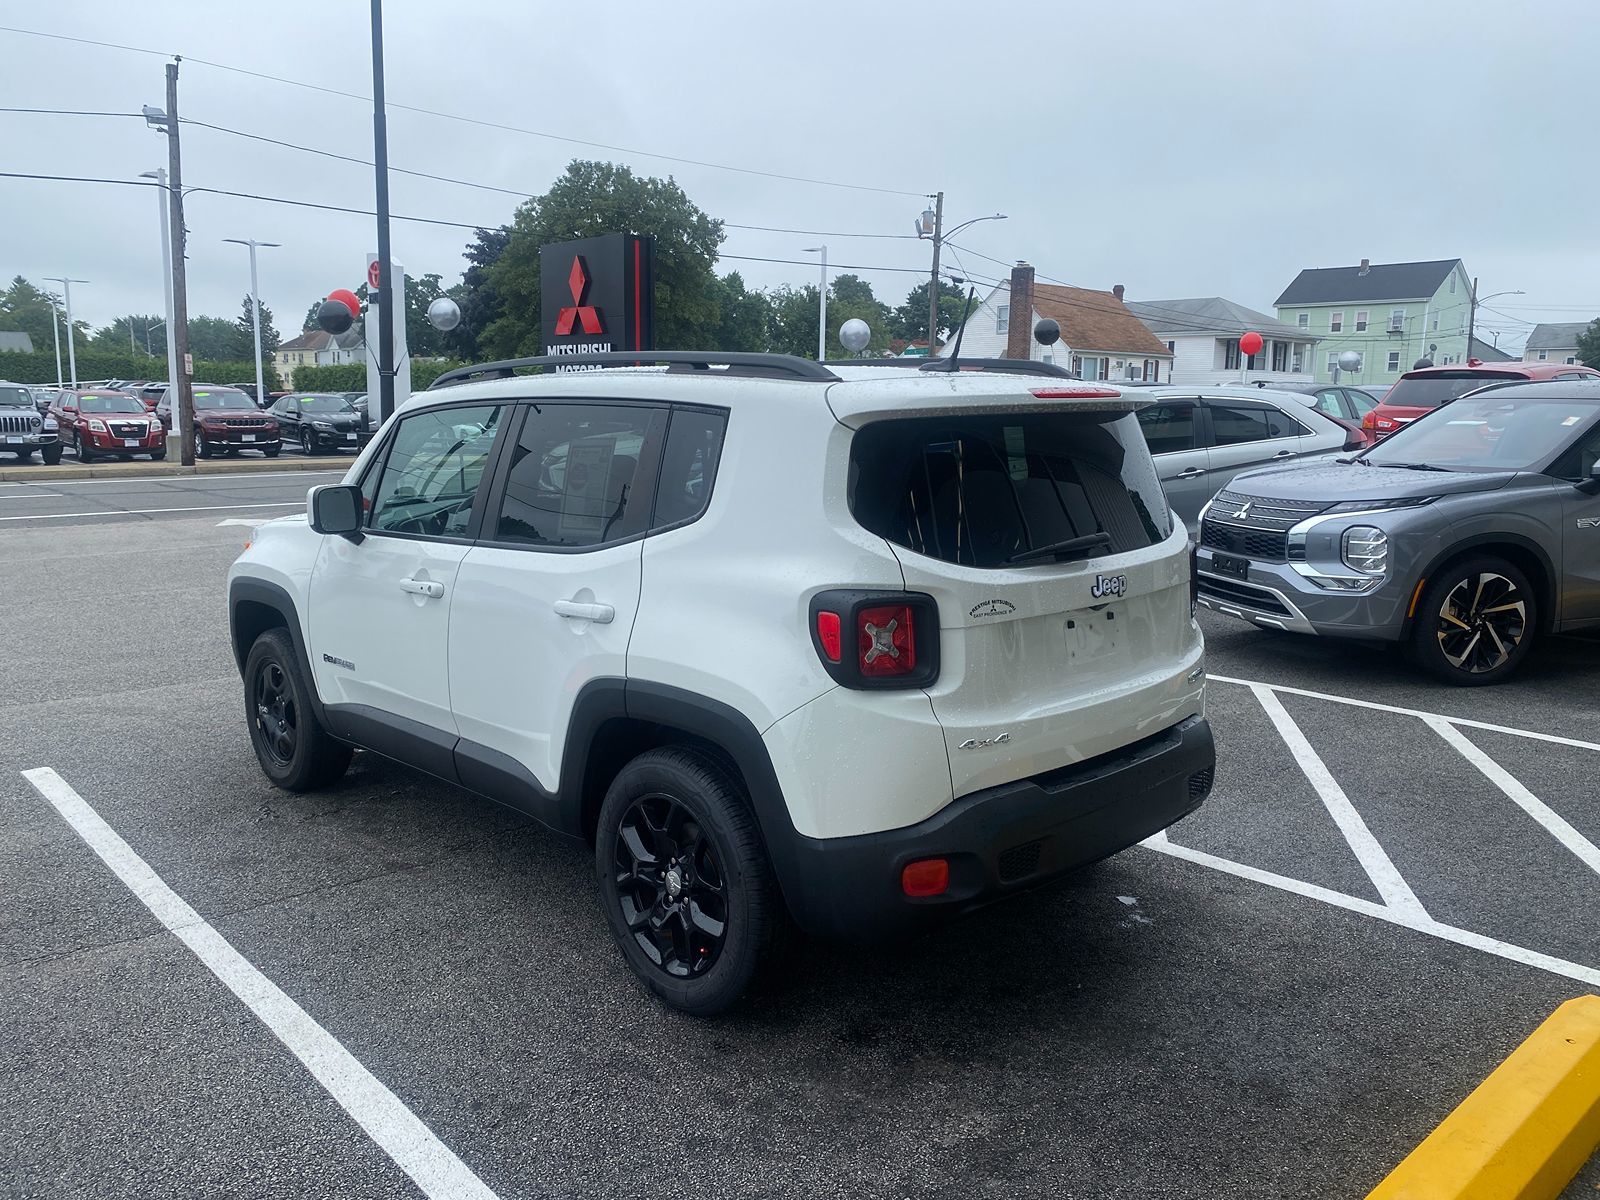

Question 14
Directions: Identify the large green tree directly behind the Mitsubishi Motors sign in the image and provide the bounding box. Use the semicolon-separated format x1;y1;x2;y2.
478;160;723;358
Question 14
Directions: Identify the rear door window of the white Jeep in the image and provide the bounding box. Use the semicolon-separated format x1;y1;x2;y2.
483;403;666;546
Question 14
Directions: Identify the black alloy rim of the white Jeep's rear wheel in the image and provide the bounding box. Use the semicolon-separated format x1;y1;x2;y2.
614;792;728;979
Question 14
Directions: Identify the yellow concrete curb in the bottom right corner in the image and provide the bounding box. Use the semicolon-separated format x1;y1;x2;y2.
1368;995;1600;1200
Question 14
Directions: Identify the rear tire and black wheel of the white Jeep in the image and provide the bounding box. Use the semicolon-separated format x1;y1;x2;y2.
595;747;782;1016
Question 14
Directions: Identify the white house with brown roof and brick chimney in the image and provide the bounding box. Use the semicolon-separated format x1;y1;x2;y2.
942;262;1173;382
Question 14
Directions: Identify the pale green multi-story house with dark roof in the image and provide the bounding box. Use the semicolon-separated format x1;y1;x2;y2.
1277;258;1472;384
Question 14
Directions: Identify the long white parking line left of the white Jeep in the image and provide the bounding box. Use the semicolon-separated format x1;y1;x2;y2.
22;766;498;1200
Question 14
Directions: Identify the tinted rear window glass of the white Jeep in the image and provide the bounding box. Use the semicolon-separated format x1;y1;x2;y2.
850;413;1171;566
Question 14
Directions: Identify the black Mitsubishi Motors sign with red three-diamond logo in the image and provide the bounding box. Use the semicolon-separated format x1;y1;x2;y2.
539;234;654;371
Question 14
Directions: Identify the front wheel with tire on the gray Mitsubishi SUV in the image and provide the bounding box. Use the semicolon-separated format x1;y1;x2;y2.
1411;555;1539;688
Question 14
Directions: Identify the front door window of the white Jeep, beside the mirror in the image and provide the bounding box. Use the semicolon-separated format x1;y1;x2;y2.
370;405;501;538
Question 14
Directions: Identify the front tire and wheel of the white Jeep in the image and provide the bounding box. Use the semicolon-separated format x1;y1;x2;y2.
245;629;352;792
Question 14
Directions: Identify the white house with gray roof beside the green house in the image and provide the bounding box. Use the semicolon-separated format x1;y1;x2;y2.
1128;296;1318;386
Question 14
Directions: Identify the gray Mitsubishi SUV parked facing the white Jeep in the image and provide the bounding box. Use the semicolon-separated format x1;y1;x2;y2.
1195;381;1600;685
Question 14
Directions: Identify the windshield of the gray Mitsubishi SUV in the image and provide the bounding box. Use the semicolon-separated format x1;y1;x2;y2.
1360;392;1600;470
